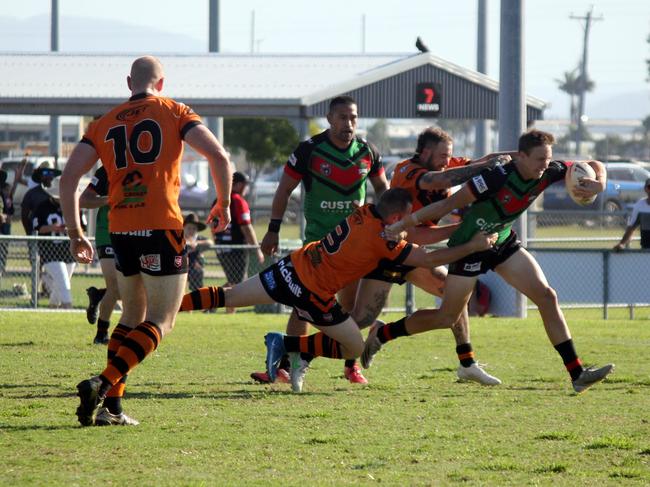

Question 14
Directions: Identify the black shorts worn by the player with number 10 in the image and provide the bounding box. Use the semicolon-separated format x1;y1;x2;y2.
111;230;188;277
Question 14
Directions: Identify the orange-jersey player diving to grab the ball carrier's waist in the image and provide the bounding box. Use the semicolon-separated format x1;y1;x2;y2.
181;188;495;392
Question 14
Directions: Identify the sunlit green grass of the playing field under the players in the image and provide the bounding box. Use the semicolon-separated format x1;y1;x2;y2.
0;312;650;486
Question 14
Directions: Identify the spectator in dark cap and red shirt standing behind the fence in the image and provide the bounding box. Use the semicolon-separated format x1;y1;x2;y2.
214;171;264;313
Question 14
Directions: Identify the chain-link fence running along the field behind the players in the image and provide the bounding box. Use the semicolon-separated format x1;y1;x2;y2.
0;211;650;314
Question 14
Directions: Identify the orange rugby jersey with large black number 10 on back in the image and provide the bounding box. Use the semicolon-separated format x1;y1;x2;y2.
81;93;201;232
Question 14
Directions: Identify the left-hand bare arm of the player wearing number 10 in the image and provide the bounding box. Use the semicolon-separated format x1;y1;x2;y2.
60;144;98;264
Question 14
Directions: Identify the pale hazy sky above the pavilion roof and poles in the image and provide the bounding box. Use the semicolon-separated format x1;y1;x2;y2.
0;0;650;118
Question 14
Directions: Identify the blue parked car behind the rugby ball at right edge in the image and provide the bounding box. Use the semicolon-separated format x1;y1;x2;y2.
543;162;650;213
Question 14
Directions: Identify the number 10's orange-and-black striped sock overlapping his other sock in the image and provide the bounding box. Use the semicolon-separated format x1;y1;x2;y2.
100;321;162;387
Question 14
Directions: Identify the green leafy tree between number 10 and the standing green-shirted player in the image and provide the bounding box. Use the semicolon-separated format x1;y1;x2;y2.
223;118;298;167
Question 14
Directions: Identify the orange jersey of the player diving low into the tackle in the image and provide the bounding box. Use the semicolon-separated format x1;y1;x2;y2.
291;205;414;297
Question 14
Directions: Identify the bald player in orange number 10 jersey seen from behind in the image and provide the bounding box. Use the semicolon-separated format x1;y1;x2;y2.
61;56;232;426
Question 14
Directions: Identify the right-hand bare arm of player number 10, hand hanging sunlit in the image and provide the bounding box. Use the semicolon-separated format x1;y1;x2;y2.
185;125;232;233
